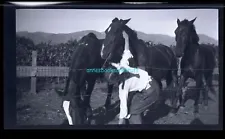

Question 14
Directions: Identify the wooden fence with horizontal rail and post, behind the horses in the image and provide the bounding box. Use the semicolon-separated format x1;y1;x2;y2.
16;51;219;93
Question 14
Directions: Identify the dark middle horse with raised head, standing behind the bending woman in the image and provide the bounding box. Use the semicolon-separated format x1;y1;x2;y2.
101;18;177;114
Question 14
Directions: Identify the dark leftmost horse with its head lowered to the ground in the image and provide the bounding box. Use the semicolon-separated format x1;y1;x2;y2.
56;33;113;125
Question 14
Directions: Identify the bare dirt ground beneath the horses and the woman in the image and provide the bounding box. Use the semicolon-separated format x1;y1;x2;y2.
17;78;219;125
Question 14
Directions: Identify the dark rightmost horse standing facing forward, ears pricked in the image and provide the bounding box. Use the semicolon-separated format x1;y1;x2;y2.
172;18;215;113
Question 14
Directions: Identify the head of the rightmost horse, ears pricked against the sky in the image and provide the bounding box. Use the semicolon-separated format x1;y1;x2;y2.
174;18;199;57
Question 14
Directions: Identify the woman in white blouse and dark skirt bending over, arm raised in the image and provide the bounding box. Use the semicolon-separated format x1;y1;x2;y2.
105;50;160;124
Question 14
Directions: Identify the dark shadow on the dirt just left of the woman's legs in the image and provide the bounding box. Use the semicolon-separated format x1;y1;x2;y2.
92;100;120;125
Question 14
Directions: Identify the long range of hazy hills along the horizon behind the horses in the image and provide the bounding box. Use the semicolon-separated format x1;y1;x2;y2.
16;30;218;46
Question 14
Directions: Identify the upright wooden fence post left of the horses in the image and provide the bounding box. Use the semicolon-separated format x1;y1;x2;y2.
31;51;37;94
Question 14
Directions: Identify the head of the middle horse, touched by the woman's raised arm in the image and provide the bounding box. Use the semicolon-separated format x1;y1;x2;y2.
101;18;130;63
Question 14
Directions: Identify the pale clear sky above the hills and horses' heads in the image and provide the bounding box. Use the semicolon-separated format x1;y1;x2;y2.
16;9;219;40
